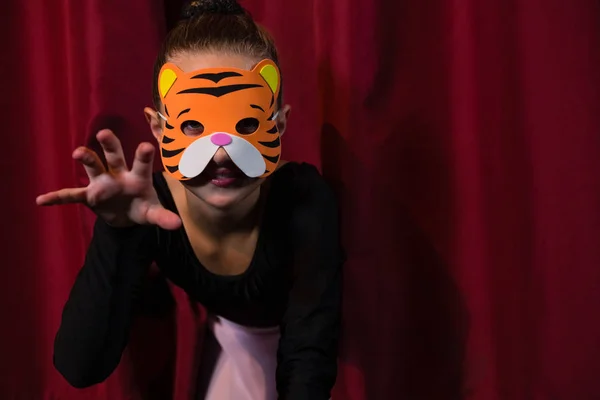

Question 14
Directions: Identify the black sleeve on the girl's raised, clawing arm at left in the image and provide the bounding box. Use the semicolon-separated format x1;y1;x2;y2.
54;218;157;388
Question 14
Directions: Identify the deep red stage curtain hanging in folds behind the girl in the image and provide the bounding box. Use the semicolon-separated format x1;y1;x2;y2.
0;0;600;400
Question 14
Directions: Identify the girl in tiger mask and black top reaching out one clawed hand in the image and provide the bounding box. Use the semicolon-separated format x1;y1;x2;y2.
37;0;343;400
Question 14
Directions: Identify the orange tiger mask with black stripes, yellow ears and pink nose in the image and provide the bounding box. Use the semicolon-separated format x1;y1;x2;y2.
158;60;281;180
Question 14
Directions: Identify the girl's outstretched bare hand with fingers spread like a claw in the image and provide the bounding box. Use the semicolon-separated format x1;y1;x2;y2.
36;130;181;230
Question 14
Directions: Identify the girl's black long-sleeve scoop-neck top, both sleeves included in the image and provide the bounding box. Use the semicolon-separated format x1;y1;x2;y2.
54;163;343;400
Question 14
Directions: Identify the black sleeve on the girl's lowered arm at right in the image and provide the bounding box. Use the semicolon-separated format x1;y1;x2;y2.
277;171;344;400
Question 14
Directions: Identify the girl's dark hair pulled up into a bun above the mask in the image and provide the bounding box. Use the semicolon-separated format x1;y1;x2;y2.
152;0;283;109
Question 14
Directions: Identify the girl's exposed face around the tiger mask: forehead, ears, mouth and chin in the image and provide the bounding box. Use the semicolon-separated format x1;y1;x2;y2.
146;52;289;209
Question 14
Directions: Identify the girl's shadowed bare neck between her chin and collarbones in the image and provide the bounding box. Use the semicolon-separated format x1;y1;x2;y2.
185;187;261;240
